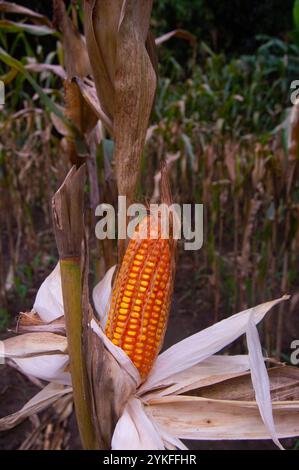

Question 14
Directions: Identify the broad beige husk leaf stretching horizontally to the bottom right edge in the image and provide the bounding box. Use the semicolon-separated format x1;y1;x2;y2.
145;395;299;440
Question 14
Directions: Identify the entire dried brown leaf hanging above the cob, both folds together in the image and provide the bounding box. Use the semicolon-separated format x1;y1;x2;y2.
84;0;157;210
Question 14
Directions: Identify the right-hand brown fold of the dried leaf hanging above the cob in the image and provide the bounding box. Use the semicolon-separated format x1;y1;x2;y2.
114;0;157;204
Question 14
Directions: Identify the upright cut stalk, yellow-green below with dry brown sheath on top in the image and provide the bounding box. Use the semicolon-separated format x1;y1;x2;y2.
53;166;96;449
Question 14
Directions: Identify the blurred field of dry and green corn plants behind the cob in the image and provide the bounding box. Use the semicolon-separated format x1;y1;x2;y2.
0;0;299;448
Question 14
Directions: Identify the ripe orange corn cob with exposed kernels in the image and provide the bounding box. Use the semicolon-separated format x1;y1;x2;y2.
106;216;173;379
